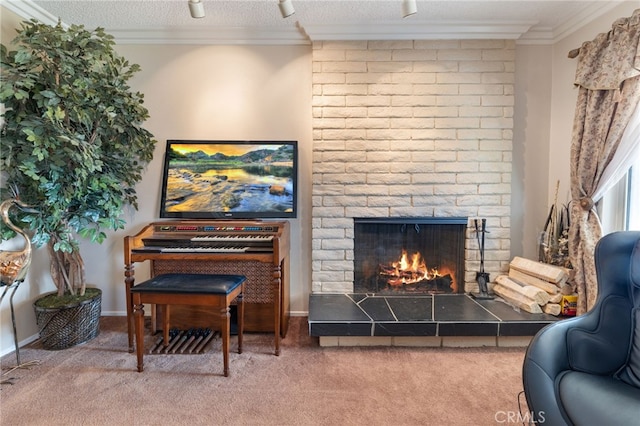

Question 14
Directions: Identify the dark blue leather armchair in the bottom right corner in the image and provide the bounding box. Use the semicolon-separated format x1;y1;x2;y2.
522;231;640;425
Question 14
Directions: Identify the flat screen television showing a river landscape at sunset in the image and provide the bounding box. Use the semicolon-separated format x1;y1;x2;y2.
160;140;298;219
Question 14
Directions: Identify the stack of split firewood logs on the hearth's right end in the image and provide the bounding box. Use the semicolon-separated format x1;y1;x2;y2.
493;256;573;316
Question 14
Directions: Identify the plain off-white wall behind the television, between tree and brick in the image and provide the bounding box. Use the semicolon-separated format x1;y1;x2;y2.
102;46;311;320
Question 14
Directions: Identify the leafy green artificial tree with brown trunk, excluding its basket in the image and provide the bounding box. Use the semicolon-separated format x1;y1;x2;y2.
0;20;156;297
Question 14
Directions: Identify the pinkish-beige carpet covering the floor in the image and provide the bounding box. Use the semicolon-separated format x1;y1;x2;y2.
0;317;526;426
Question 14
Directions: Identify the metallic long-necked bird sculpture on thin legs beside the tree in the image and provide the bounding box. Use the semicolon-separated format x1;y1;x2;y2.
0;198;36;366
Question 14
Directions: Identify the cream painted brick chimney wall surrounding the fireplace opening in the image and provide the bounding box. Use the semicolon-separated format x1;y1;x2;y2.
312;40;515;293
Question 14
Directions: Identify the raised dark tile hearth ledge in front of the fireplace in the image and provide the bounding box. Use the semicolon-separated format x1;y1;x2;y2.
309;293;558;337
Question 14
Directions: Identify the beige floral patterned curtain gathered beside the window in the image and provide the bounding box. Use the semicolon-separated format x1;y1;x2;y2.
569;9;640;314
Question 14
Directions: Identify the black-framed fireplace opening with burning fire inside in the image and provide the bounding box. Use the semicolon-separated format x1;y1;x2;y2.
354;217;467;294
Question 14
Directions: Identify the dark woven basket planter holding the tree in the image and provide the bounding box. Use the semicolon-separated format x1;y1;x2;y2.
33;289;102;350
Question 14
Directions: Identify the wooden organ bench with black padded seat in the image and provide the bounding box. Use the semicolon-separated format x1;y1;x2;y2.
131;273;246;377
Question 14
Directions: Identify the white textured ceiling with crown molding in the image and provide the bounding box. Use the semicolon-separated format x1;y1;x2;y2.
3;0;637;43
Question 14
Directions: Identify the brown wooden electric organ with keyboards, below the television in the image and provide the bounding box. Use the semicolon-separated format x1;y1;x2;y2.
124;220;290;354
